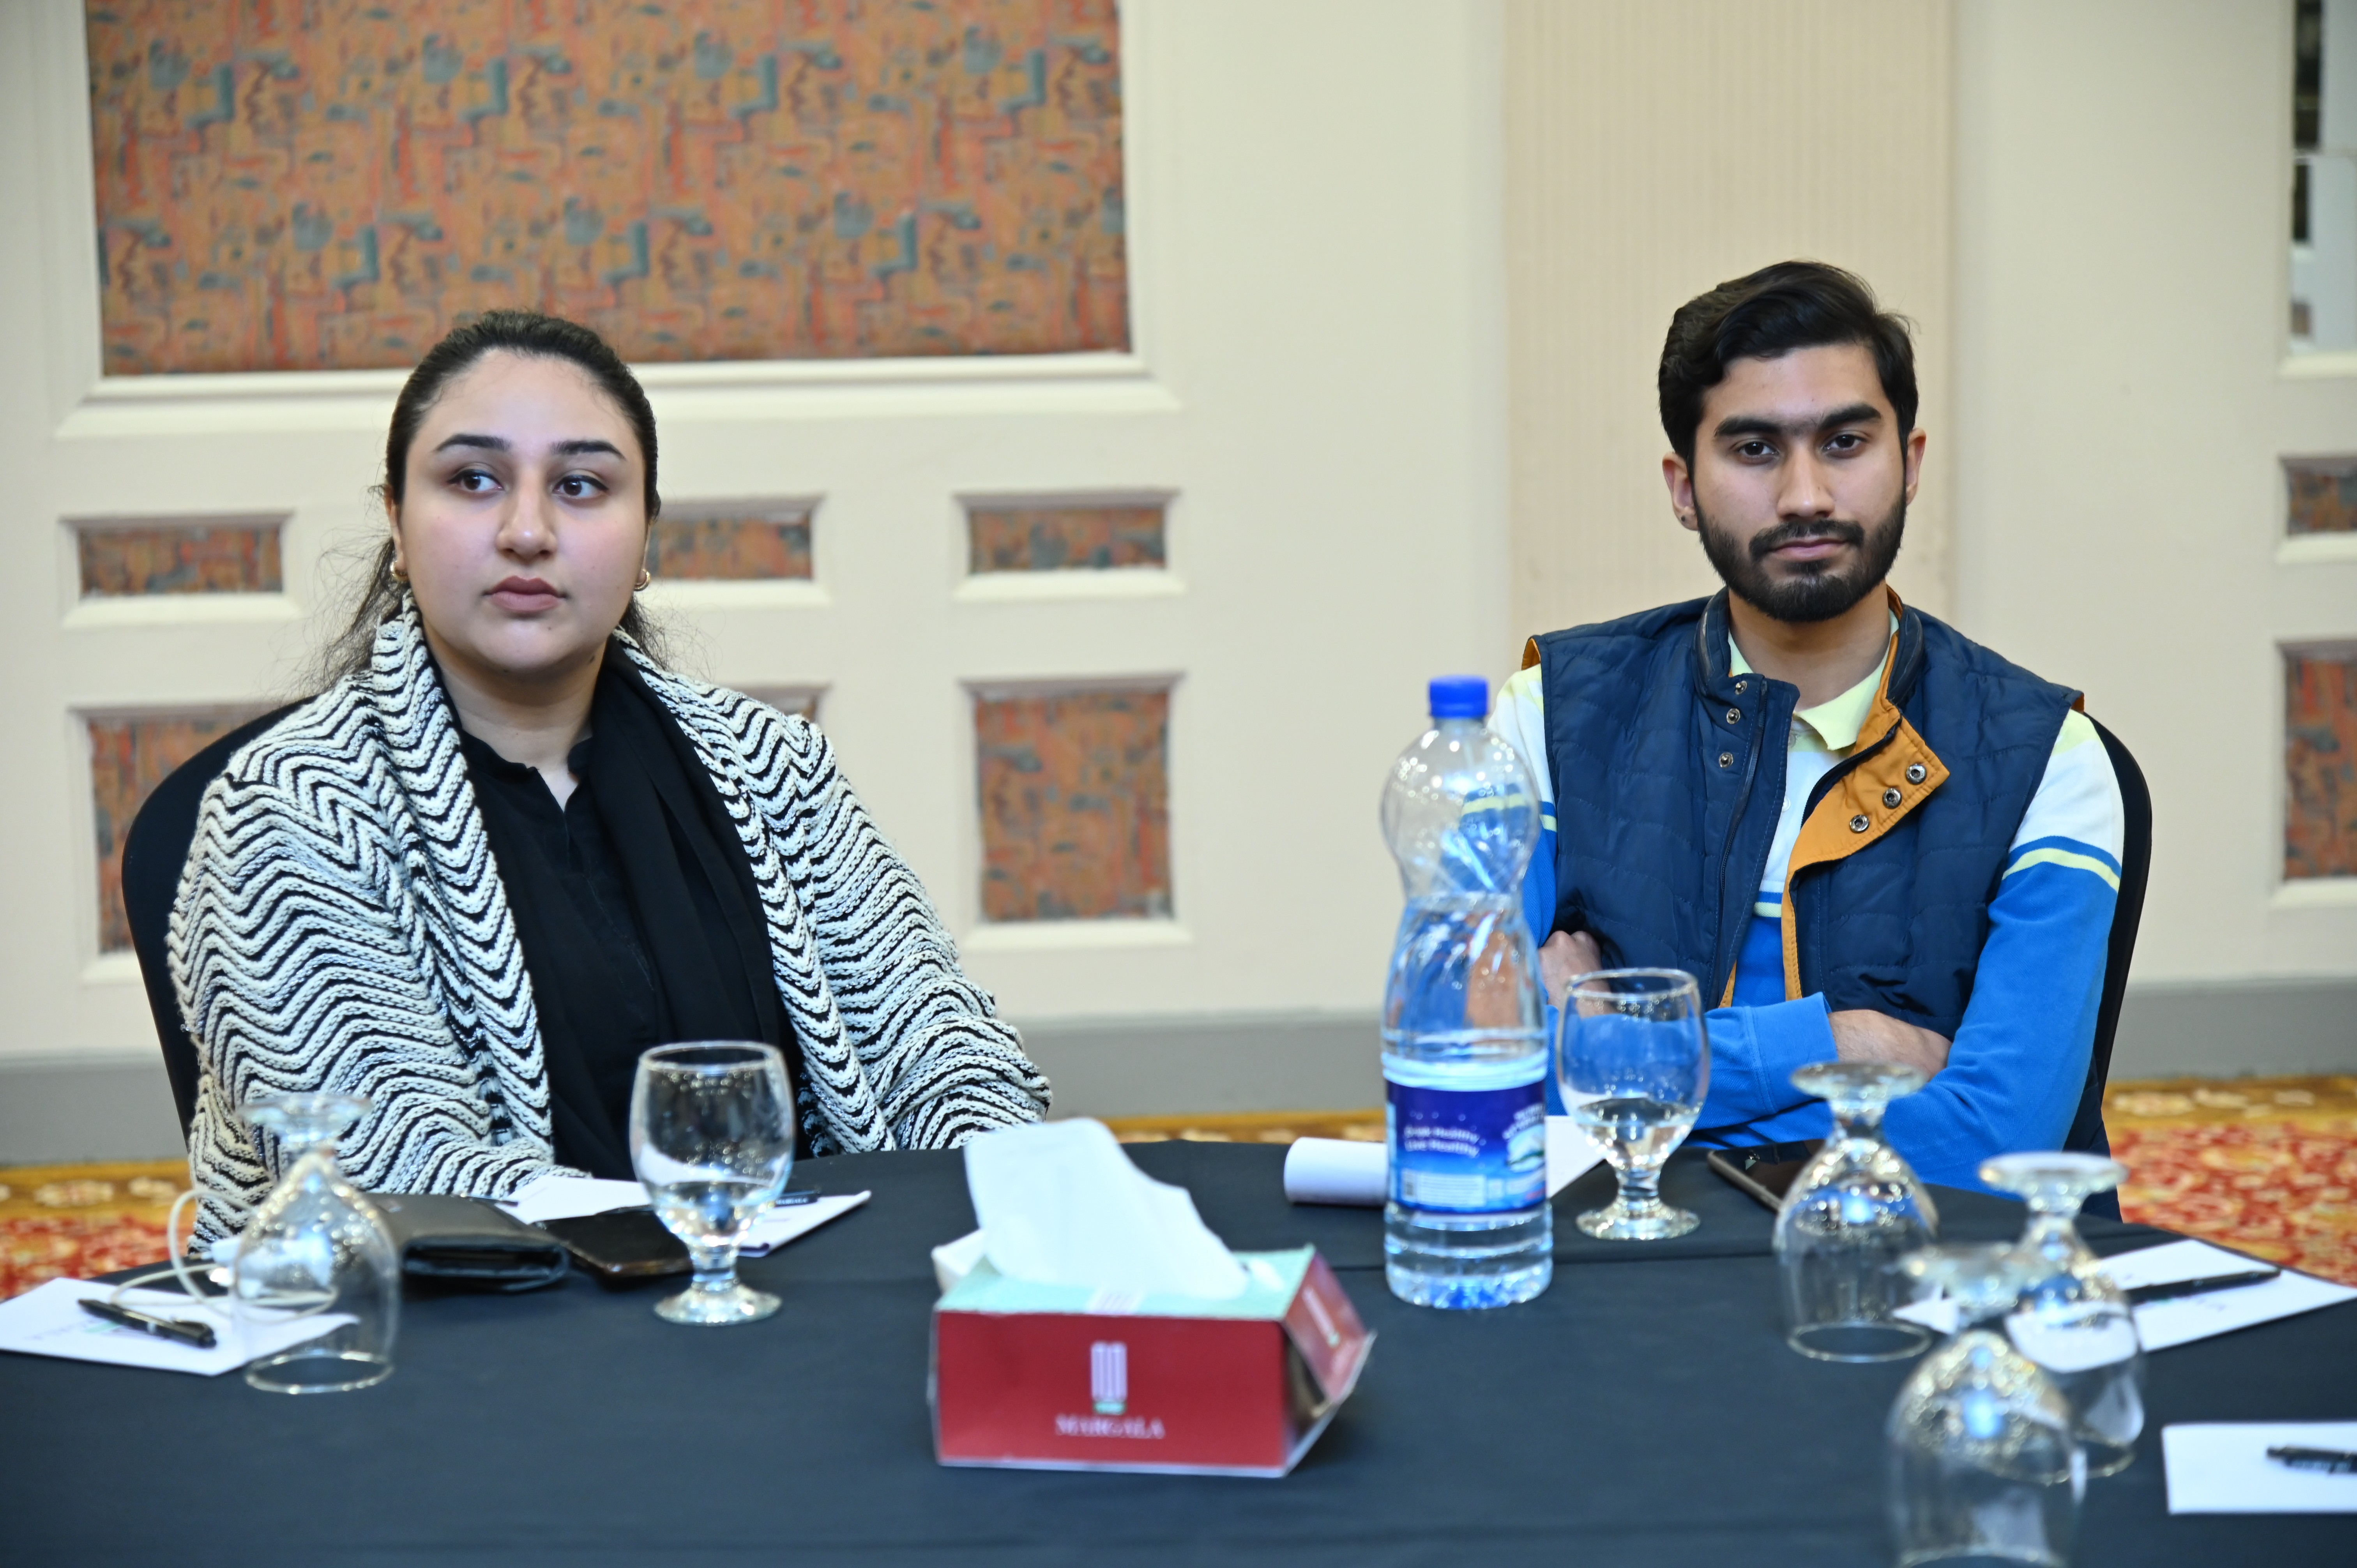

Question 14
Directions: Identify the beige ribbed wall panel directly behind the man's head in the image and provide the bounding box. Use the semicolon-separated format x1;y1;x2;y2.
1497;0;1963;646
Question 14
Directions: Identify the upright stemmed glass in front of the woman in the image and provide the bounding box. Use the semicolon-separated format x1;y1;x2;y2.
629;1040;794;1325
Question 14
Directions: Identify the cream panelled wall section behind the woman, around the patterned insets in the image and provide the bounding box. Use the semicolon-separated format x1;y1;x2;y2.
0;0;1509;1113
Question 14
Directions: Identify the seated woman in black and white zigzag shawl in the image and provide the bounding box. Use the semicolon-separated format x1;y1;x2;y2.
188;311;1049;1236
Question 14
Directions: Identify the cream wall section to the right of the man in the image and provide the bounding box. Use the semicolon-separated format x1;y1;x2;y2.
1956;0;2357;1014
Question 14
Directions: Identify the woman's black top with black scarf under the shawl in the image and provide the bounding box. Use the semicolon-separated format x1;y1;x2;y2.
459;651;799;1179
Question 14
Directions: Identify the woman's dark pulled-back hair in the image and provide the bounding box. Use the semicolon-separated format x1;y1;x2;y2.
316;311;662;689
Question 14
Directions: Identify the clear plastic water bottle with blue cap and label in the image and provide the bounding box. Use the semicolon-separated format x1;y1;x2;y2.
1383;675;1556;1306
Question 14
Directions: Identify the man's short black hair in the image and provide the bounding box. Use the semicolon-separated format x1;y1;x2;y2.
1659;262;1916;464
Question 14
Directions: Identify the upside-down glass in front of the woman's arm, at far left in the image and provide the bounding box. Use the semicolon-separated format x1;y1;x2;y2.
229;1094;401;1393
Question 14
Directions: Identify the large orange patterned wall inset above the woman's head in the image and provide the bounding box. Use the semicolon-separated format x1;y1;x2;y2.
85;0;1129;375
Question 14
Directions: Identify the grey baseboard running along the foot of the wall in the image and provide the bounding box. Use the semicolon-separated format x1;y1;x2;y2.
0;978;2357;1165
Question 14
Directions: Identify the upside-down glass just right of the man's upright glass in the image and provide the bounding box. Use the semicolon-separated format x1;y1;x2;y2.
1775;1061;1940;1361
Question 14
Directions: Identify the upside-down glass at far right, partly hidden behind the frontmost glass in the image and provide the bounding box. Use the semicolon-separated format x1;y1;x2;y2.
1980;1153;2145;1476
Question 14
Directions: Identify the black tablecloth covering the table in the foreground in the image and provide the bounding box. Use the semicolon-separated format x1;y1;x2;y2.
0;1144;2357;1568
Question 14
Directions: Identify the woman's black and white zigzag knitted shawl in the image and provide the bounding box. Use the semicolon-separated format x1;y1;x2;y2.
170;604;1049;1236
